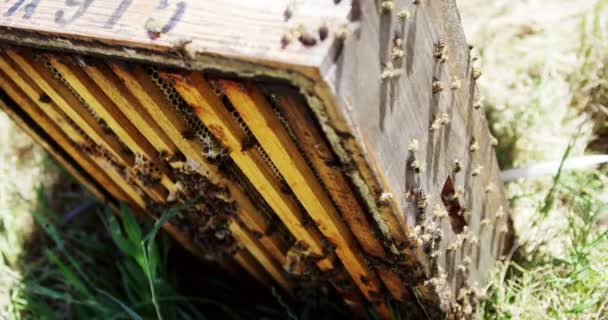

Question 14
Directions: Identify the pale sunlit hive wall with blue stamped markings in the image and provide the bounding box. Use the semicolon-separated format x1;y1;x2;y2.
0;0;350;77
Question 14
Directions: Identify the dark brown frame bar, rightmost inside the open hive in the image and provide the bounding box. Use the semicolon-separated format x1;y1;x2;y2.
272;87;409;301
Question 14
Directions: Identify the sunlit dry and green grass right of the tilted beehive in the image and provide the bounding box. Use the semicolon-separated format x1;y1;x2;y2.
458;0;608;319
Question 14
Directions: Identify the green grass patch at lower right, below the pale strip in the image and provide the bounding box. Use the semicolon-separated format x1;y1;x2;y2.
480;160;608;319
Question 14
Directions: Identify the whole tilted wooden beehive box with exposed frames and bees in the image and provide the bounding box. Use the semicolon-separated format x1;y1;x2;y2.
0;0;511;318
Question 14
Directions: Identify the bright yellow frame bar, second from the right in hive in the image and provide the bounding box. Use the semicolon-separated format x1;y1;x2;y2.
219;80;388;310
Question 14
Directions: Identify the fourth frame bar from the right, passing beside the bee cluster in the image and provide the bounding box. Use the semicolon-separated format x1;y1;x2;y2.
110;64;287;264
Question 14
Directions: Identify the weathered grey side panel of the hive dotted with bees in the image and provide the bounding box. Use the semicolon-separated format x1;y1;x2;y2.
317;1;508;304
